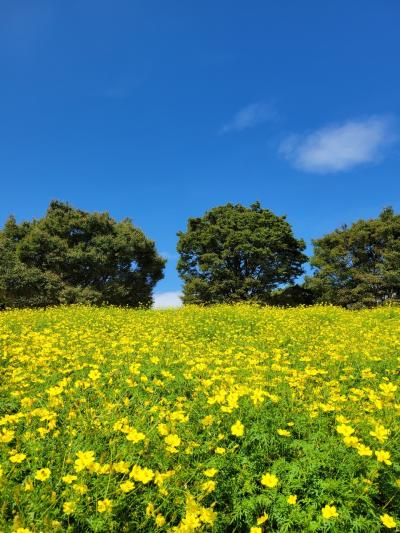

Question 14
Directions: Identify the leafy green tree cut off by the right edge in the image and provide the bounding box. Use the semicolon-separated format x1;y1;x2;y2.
305;208;400;308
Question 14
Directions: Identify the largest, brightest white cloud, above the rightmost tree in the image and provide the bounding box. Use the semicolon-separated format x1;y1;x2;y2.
280;116;395;174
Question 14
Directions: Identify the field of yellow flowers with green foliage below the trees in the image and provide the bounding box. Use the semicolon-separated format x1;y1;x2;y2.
0;305;400;533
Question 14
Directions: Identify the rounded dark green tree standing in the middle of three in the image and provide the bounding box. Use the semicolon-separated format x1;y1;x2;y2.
177;202;307;304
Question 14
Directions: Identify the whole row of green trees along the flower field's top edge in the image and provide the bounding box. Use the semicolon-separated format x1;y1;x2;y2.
0;201;400;309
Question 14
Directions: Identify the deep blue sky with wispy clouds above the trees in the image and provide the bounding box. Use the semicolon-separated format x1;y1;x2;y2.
0;0;400;302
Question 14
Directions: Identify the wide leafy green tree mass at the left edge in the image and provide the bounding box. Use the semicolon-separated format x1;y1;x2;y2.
0;201;165;307
